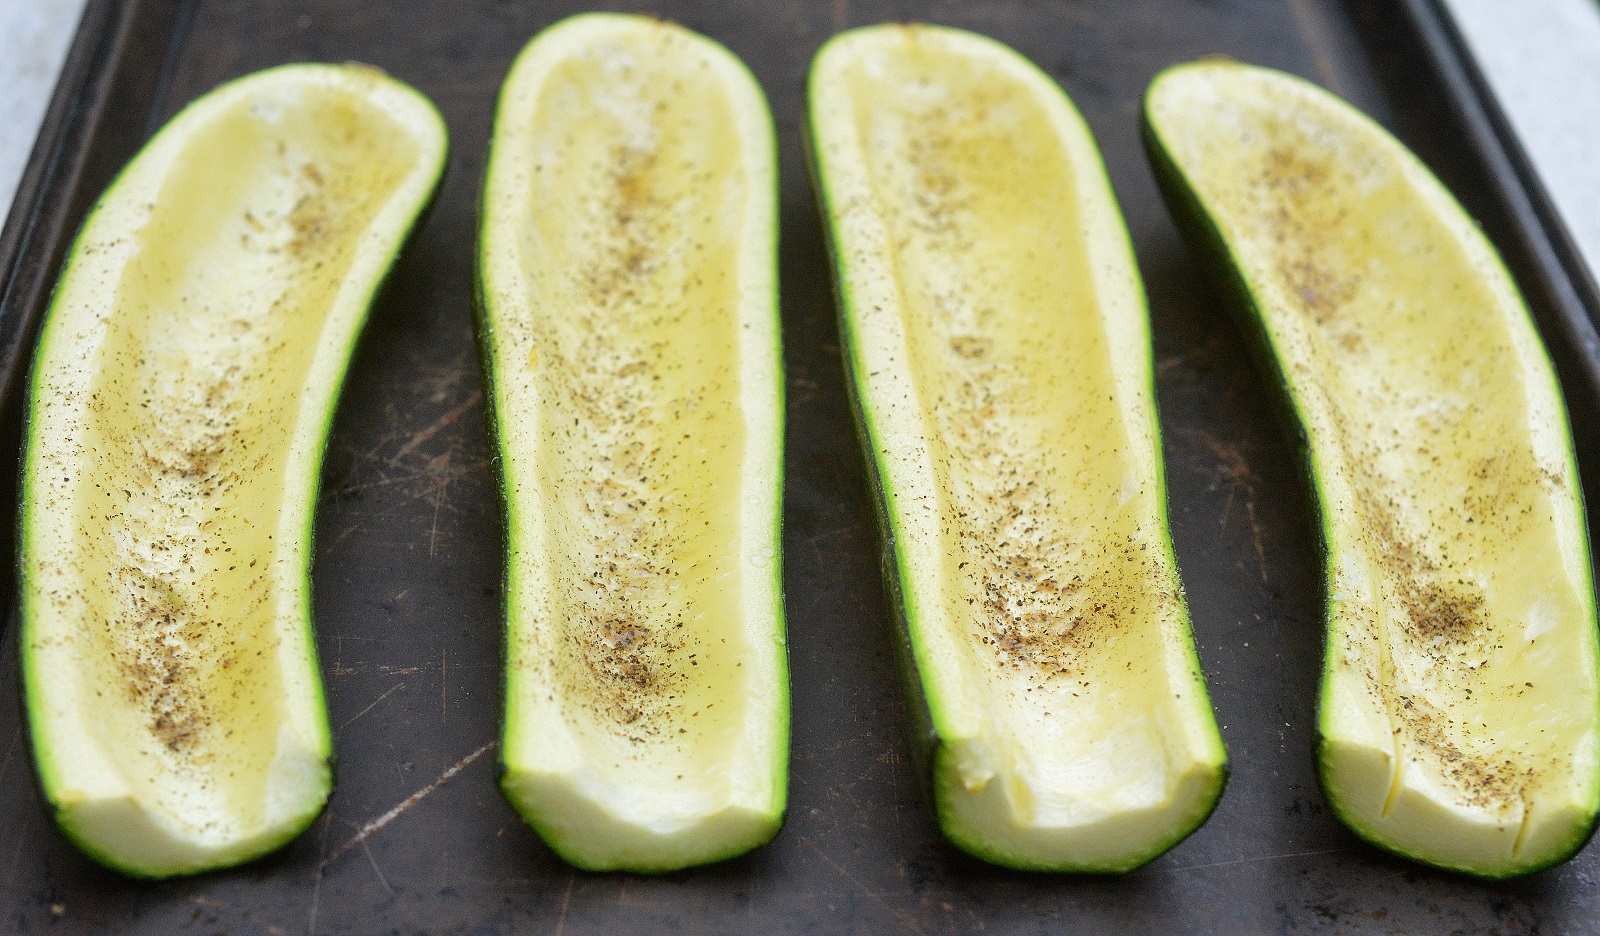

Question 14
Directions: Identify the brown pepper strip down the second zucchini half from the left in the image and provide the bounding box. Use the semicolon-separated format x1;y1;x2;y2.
534;112;726;744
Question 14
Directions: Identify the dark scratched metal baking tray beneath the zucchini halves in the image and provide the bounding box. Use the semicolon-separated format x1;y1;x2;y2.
0;0;1600;936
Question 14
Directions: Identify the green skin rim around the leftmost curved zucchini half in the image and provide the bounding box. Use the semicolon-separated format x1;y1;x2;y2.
16;62;448;880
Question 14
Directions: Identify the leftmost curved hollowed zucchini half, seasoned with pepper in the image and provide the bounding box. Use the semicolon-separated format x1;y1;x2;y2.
19;66;445;877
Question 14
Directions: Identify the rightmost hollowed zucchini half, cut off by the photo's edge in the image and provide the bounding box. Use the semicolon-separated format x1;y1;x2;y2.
1144;61;1600;877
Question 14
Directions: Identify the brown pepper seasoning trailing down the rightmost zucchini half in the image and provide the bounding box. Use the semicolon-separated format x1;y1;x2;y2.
1246;125;1538;806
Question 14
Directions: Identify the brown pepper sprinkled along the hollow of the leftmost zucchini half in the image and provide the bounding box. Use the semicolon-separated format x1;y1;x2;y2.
90;153;348;768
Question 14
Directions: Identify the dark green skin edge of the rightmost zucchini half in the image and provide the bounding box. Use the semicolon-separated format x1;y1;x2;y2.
1139;64;1600;880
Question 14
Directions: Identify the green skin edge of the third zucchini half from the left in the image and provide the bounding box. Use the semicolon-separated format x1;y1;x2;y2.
802;24;1229;874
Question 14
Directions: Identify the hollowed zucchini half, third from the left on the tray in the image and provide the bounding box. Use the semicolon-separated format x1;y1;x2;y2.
808;24;1226;870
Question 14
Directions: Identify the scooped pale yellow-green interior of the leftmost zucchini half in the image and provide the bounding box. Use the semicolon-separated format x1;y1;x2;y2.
49;86;419;840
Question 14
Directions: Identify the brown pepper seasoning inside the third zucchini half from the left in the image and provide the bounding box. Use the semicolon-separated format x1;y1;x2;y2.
882;91;1179;682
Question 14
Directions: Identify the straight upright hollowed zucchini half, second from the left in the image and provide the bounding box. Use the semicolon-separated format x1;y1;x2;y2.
478;14;789;872
